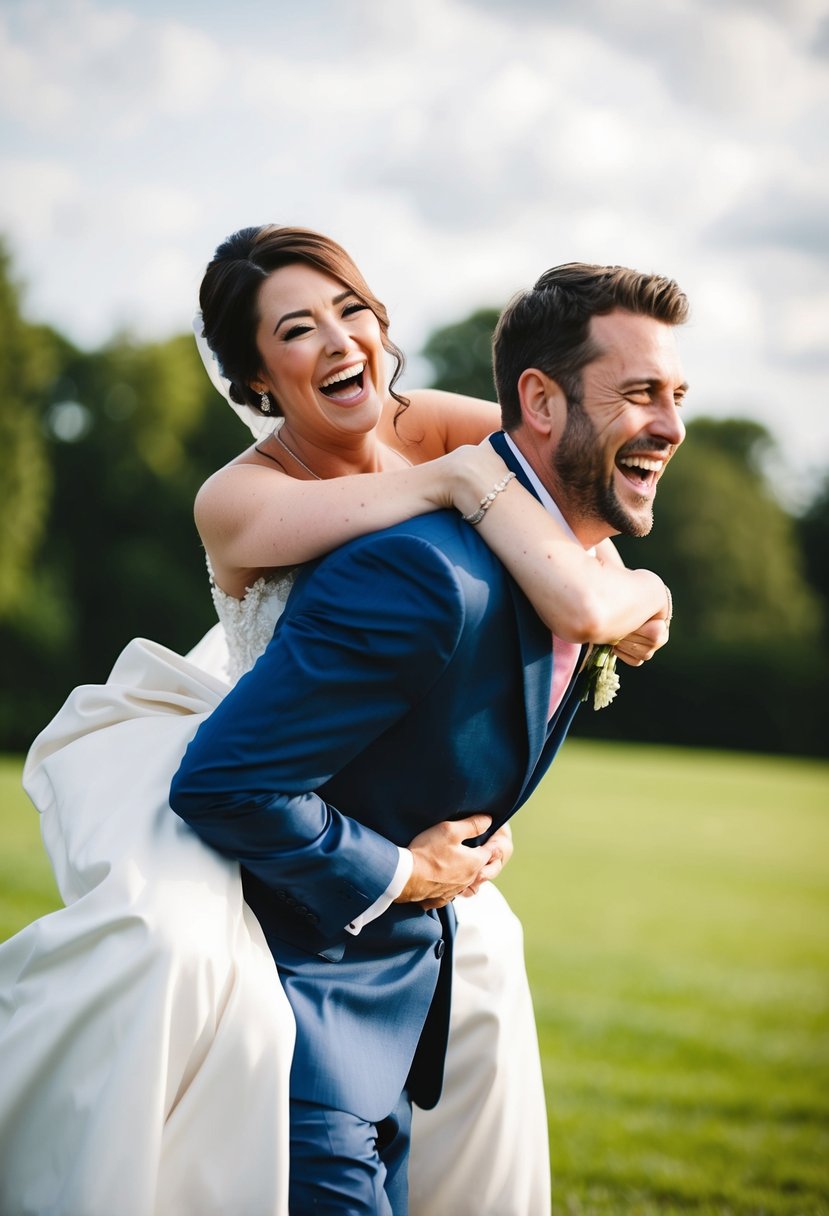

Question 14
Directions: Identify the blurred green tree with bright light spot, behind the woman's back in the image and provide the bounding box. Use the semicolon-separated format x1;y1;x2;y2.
0;301;248;749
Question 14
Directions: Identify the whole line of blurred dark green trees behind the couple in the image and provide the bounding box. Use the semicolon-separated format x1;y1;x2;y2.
0;247;829;755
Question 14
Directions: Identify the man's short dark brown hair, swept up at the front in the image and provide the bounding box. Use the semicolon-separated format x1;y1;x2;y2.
492;261;688;430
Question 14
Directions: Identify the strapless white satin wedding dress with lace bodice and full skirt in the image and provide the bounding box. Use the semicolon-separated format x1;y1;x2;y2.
0;578;549;1216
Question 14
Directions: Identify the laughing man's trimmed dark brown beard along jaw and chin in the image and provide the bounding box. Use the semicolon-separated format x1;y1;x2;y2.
552;399;654;536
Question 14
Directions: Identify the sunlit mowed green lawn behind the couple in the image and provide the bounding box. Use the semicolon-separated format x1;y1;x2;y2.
0;739;829;1216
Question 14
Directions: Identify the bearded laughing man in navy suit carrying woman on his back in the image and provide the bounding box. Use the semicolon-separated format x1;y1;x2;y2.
171;264;687;1216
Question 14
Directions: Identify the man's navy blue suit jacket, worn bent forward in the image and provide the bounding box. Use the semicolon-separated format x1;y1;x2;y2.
171;437;579;1120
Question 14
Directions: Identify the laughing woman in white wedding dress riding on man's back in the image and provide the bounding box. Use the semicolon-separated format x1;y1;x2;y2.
0;226;666;1216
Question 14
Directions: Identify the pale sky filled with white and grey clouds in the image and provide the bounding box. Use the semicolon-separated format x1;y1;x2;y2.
0;0;829;492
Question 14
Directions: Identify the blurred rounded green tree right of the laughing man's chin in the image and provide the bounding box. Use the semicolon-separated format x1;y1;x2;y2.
588;418;829;754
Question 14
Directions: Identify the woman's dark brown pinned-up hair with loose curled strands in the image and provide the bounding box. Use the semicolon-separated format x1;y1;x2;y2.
199;224;408;411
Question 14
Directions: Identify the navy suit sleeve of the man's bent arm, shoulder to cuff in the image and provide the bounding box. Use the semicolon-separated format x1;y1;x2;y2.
170;533;471;935
